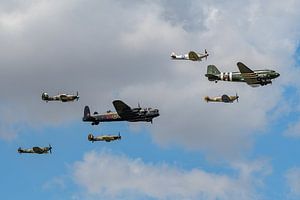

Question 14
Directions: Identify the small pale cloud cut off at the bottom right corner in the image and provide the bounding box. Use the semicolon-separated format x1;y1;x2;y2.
285;167;300;199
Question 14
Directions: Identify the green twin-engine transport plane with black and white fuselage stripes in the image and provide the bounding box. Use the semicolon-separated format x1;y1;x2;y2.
205;62;280;87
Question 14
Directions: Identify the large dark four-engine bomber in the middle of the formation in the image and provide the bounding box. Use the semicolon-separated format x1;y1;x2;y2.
82;100;159;125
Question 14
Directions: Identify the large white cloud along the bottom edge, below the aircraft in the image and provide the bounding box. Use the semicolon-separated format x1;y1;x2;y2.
73;151;270;200
